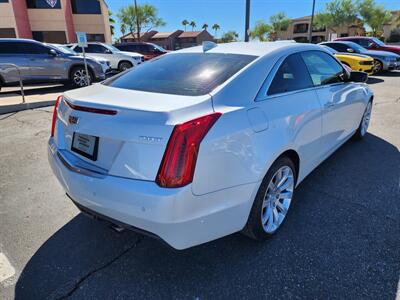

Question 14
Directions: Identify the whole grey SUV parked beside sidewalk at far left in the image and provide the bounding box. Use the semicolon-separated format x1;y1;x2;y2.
0;39;105;87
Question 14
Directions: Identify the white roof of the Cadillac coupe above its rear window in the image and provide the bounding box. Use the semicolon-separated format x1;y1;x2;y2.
175;41;323;56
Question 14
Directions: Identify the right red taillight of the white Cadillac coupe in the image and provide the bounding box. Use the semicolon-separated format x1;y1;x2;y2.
156;113;221;188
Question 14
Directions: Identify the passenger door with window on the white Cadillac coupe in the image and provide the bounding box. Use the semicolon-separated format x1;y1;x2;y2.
301;51;364;155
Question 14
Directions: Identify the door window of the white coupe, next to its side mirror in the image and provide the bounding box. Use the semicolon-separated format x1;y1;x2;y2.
301;51;344;86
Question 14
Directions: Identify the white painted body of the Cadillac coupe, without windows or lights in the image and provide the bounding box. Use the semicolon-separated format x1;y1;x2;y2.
49;42;372;249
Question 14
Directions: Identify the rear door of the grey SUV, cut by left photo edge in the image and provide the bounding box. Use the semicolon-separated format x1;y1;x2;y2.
0;42;31;83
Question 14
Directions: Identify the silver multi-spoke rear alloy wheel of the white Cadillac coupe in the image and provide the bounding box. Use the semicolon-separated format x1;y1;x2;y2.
261;166;294;234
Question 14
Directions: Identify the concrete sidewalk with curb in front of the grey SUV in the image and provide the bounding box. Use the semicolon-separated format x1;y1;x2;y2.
0;85;68;115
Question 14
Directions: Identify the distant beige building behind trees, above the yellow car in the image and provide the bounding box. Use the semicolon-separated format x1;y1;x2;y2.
277;16;365;43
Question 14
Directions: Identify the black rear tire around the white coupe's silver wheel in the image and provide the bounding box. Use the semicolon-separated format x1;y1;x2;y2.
242;156;297;241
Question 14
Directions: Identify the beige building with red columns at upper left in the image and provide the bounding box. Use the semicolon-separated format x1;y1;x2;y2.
0;0;112;43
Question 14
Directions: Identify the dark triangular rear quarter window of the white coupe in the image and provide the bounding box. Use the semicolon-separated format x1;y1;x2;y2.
267;53;313;95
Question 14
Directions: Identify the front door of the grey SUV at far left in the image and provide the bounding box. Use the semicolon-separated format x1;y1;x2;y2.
24;42;66;81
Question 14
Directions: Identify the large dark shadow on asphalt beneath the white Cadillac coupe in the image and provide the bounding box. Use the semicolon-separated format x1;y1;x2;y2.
15;134;400;299
